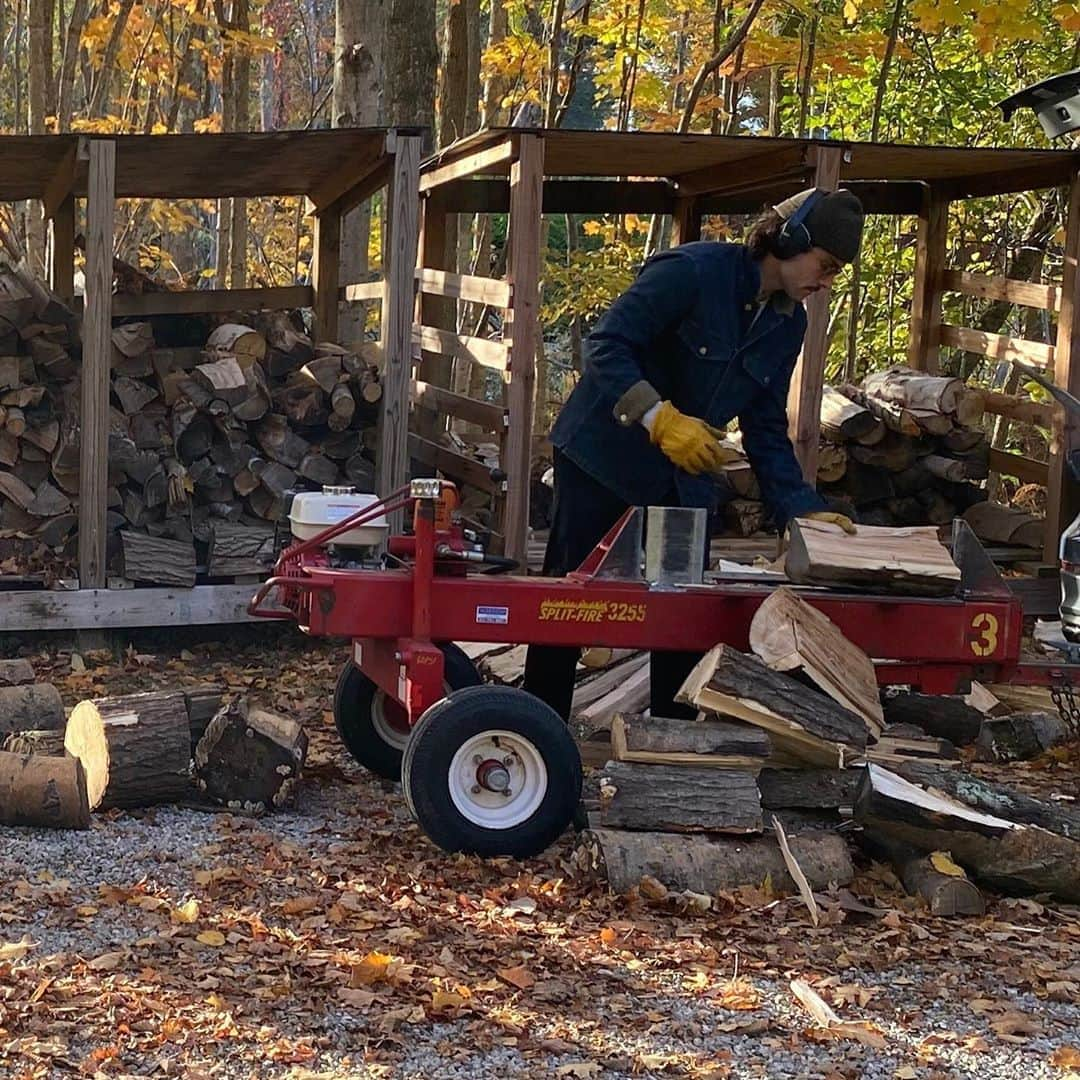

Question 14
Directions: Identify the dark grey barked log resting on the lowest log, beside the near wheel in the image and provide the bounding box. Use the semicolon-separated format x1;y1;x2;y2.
599;761;764;834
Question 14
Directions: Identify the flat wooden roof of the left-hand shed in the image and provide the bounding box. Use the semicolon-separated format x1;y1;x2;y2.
0;127;416;205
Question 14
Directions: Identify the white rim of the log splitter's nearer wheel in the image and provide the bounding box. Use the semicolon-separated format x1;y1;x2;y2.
447;730;548;829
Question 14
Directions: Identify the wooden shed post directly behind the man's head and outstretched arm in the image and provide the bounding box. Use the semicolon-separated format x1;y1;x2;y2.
787;147;846;486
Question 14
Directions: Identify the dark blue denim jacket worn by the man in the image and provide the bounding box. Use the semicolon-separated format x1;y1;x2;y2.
551;242;825;525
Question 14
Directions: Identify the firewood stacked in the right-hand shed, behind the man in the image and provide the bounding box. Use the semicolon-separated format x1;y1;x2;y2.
725;368;1041;548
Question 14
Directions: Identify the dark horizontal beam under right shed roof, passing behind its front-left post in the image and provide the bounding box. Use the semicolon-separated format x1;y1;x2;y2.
428;178;674;214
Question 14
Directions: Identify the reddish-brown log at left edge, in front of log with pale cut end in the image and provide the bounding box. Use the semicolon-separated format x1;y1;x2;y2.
0;751;90;828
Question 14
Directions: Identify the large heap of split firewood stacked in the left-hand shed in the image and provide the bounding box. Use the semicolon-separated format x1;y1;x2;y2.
0;262;382;585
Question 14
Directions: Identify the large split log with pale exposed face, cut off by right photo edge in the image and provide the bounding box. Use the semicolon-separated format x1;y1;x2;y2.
855;765;1080;902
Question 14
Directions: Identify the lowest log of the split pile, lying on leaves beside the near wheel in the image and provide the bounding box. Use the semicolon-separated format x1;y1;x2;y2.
576;828;855;896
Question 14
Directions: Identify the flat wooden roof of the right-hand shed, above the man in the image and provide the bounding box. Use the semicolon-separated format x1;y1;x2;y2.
423;127;1080;198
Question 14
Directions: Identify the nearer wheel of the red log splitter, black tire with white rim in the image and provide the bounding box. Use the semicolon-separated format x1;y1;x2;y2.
402;686;581;859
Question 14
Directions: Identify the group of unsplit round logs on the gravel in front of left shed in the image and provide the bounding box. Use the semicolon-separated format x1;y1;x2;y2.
0;648;308;829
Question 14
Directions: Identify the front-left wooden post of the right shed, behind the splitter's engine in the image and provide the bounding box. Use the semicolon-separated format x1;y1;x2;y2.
502;135;543;568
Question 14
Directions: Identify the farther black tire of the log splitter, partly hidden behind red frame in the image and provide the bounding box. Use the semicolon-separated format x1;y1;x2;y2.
334;645;481;780
